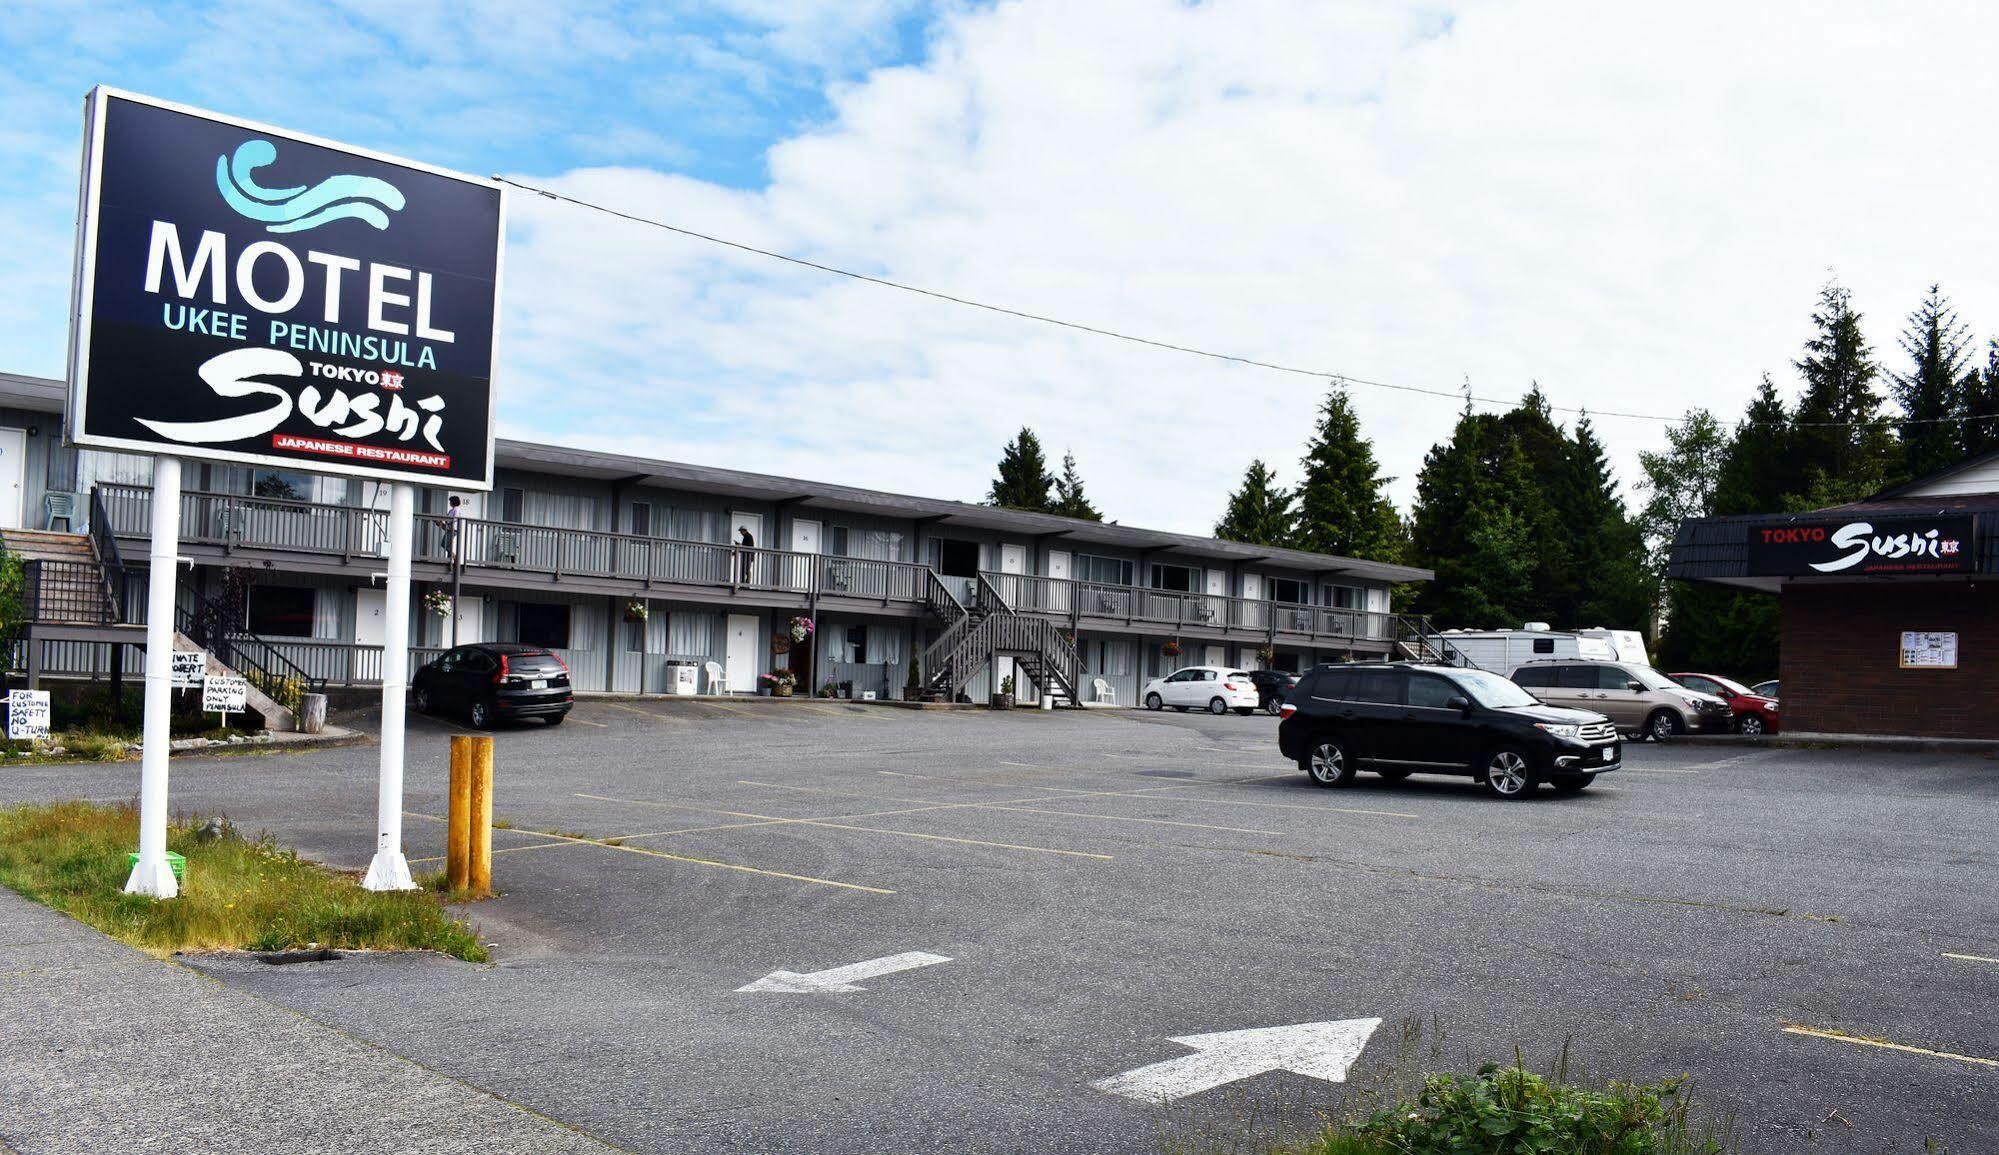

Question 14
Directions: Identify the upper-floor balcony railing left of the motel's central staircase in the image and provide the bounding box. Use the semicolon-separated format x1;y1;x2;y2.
100;486;926;603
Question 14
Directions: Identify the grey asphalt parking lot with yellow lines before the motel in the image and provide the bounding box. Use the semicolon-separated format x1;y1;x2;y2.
0;701;1999;1153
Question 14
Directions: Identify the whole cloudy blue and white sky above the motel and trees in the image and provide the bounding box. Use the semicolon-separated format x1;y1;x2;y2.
0;0;1999;532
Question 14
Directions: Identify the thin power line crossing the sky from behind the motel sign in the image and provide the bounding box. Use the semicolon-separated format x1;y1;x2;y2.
494;172;1999;430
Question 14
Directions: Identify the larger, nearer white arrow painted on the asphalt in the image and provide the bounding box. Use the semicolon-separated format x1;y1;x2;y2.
1093;1019;1381;1103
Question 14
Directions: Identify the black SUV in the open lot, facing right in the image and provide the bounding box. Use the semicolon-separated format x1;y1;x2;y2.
1277;663;1619;797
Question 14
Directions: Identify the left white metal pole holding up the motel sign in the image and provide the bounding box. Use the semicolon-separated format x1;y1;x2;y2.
126;458;180;899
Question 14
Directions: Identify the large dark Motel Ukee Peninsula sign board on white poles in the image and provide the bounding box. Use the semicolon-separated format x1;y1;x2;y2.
68;88;506;490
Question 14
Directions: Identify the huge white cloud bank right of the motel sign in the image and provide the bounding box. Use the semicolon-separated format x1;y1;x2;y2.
491;0;1999;532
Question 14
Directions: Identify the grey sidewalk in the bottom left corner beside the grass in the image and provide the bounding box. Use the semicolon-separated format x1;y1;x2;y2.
0;889;618;1155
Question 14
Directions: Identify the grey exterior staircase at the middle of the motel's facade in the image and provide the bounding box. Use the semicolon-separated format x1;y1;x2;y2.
924;574;1083;705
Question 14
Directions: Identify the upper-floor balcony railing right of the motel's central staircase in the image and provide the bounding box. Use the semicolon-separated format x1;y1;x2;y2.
986;574;1397;641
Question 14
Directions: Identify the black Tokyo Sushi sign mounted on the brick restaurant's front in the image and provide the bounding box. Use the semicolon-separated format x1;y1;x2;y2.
1747;514;1977;578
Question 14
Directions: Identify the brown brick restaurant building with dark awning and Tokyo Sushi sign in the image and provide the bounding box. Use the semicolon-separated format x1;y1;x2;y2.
1667;454;1999;739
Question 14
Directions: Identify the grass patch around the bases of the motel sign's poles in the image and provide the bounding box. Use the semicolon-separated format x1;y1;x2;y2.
0;801;486;963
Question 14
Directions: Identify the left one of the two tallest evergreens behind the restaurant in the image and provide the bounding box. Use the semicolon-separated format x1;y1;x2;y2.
1793;282;1899;506
